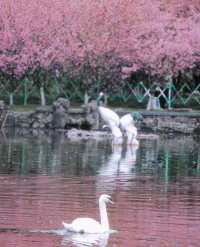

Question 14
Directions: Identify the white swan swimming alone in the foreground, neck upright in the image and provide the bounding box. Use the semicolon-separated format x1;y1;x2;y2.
63;194;113;234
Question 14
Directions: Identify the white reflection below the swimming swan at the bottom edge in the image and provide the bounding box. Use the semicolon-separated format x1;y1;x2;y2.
62;233;110;247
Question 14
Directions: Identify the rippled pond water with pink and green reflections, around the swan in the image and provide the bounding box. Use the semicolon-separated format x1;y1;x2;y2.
0;130;200;247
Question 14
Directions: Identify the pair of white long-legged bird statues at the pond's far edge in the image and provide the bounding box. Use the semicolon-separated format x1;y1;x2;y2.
97;92;142;145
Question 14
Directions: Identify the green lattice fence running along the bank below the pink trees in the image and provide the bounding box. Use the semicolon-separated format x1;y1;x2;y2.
0;78;200;108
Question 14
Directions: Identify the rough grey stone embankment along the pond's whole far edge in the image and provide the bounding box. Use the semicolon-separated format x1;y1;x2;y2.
1;98;200;134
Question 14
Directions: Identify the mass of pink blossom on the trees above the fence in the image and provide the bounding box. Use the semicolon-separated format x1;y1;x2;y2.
0;0;200;75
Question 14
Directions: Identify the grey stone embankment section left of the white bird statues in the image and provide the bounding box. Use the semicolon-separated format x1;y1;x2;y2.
5;98;98;130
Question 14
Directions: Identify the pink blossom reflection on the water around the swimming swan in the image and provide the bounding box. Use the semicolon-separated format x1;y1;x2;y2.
0;176;200;247
